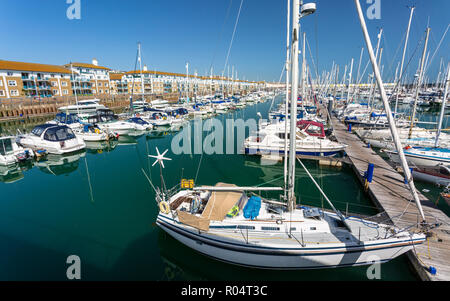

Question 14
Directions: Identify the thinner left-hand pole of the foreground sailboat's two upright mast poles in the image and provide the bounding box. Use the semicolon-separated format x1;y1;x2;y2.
283;0;291;200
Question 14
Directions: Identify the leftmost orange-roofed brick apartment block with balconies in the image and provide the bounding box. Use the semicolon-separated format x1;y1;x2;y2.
0;60;72;98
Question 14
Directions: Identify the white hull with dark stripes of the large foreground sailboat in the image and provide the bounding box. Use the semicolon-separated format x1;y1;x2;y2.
156;217;423;270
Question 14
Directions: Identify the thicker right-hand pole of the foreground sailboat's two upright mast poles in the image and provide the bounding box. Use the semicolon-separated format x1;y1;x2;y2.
285;0;300;212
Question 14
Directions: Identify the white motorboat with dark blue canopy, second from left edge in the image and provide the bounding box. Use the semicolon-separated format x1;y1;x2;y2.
17;124;86;155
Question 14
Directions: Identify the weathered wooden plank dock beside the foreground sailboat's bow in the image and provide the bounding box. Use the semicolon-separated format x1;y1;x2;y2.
332;113;450;281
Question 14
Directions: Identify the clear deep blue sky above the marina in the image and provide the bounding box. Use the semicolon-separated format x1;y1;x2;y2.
0;0;450;81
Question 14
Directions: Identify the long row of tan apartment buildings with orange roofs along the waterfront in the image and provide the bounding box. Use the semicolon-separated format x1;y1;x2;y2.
0;59;265;98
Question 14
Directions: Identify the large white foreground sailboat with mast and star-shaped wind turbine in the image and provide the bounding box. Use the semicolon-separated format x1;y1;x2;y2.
149;0;425;270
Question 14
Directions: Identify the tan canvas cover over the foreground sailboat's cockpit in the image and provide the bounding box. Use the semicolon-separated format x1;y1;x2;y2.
202;183;245;221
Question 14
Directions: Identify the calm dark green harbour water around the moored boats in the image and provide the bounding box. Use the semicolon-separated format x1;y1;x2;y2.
0;96;417;280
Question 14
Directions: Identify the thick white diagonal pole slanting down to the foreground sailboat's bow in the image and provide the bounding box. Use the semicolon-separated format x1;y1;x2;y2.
355;0;425;222
